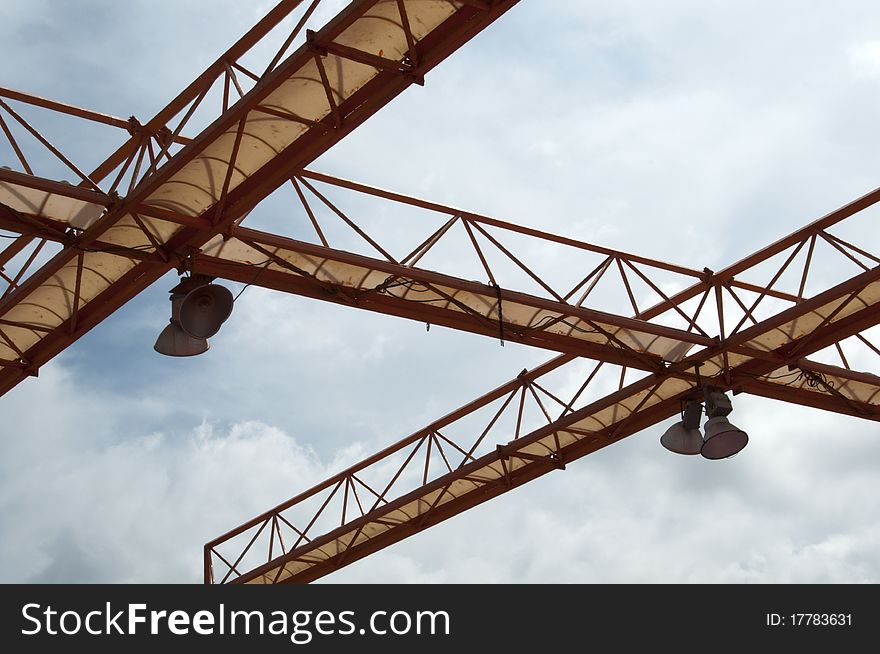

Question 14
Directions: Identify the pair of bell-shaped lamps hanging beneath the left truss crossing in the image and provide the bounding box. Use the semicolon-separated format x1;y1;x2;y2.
153;275;233;357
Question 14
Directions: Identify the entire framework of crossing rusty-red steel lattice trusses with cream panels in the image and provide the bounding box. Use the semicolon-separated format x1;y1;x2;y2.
0;0;880;583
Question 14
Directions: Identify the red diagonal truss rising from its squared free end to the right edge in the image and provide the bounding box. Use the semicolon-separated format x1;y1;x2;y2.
199;184;880;583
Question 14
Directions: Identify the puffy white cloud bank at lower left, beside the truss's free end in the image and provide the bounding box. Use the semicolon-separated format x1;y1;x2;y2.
0;373;364;582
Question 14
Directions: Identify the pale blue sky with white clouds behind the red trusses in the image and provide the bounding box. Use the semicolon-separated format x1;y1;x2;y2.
0;0;880;582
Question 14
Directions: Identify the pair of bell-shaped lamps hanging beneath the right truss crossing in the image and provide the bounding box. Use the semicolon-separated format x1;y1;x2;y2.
660;386;749;460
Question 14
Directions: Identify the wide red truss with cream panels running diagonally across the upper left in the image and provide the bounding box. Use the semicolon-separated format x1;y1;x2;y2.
0;0;516;394
